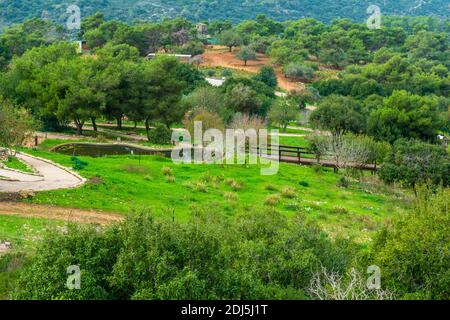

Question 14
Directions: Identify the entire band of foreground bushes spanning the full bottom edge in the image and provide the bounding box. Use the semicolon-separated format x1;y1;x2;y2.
0;189;450;299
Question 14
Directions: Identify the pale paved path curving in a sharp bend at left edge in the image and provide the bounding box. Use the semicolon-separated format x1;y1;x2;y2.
0;153;86;193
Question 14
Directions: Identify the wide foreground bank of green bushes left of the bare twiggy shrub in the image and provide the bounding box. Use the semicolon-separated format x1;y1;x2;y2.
15;212;353;299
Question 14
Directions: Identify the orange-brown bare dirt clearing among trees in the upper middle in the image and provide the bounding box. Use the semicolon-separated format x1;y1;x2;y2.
202;46;305;91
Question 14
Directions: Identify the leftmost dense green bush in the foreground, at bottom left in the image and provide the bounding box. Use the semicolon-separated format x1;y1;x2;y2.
13;225;123;300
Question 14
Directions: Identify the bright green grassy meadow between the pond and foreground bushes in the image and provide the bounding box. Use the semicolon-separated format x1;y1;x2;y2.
16;145;408;241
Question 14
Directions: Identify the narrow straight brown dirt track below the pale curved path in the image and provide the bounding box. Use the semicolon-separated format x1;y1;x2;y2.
0;202;123;225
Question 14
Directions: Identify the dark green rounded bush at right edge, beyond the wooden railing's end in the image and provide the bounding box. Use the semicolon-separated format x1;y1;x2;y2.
379;139;450;188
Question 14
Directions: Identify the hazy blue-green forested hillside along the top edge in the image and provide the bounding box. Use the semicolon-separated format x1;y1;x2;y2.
0;0;449;27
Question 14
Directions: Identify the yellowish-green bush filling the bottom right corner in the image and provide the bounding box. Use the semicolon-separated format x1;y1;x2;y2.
369;188;450;300
